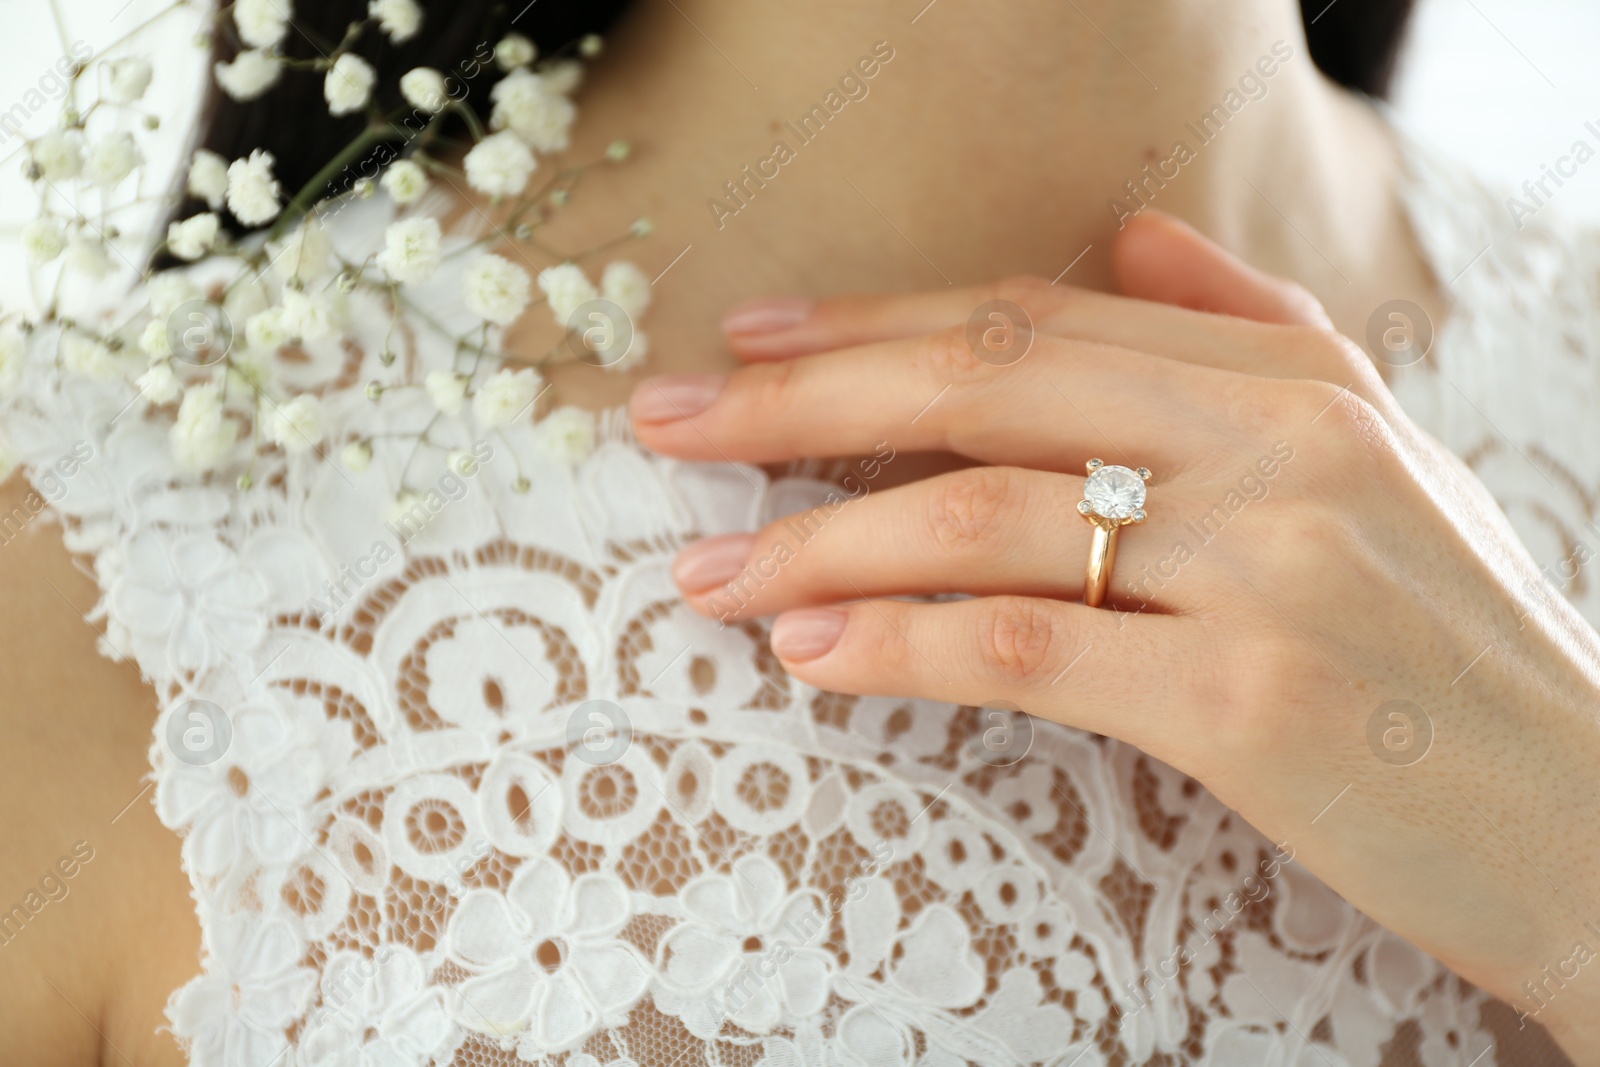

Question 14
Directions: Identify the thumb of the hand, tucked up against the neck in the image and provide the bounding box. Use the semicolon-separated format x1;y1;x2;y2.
1110;208;1333;326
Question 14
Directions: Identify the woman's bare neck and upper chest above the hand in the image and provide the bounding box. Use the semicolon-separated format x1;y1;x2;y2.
514;0;1427;402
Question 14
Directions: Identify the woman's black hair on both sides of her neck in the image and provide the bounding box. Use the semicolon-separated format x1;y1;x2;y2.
190;0;1413;229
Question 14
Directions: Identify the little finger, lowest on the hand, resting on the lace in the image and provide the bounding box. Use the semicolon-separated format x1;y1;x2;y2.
771;597;1213;744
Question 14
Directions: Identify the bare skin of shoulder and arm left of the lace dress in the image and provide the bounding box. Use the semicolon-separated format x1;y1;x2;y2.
0;477;200;1065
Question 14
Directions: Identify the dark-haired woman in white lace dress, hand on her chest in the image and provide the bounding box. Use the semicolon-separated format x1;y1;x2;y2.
0;0;1600;1067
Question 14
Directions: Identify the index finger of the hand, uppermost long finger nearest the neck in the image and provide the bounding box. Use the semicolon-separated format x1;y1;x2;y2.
723;275;1325;378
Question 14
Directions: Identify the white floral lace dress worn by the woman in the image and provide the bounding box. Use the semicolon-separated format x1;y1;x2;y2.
5;129;1600;1067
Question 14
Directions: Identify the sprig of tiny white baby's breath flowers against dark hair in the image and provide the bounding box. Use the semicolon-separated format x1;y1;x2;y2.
0;0;651;496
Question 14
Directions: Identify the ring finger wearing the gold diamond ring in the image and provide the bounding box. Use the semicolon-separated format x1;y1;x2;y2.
672;467;1194;621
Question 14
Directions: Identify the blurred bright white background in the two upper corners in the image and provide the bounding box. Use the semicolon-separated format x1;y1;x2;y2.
0;0;1600;307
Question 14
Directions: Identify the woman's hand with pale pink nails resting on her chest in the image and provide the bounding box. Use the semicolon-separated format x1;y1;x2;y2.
634;213;1600;1062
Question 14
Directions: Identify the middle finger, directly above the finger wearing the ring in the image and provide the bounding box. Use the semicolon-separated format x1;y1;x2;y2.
630;331;1216;480
